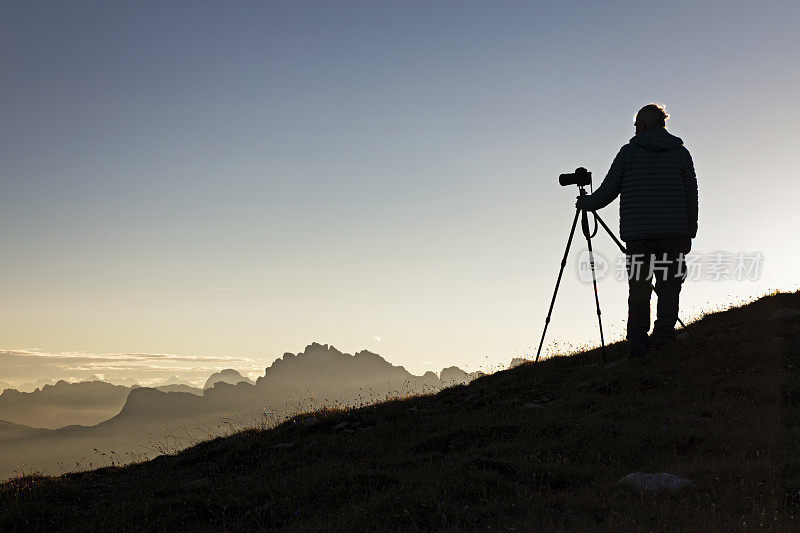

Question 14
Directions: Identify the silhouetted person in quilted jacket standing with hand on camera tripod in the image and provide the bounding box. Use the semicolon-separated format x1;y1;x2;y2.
577;104;697;356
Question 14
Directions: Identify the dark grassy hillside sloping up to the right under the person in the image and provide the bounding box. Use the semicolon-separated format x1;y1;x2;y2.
0;293;800;531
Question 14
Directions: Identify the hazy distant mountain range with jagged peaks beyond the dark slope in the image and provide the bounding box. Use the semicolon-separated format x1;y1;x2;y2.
0;343;478;479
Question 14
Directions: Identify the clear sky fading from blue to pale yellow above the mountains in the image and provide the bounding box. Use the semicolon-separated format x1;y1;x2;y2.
0;1;800;381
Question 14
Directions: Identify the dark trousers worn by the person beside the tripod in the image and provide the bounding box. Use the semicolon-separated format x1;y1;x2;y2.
626;237;692;348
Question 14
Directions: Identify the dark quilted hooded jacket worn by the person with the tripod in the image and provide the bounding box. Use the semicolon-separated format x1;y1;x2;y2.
583;128;697;241
